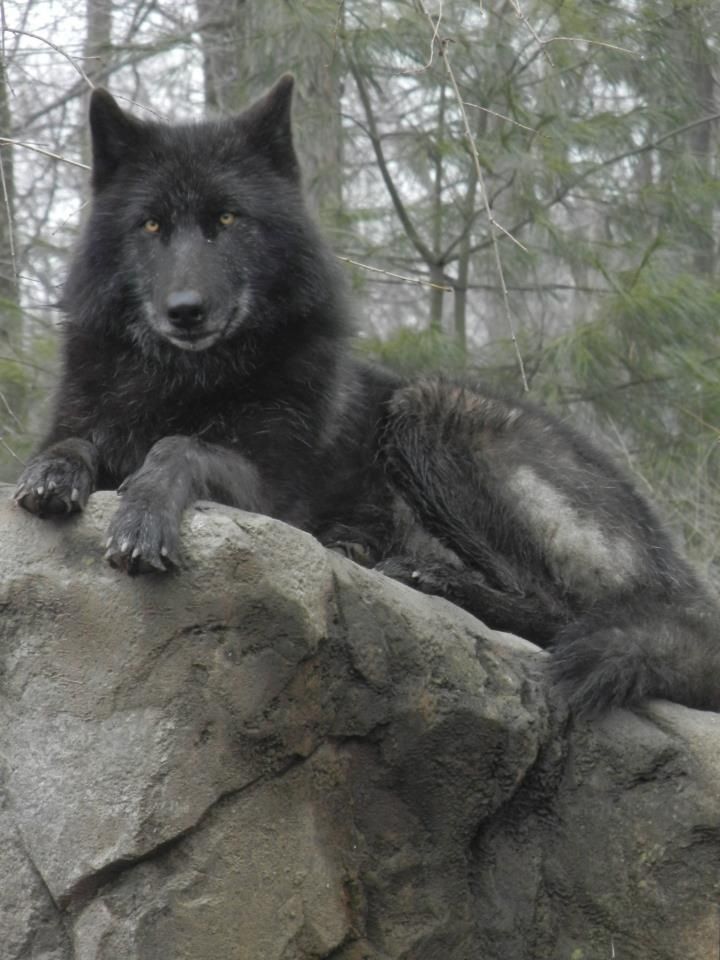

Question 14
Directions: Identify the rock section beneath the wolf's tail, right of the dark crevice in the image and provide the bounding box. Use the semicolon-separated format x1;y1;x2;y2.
473;702;720;960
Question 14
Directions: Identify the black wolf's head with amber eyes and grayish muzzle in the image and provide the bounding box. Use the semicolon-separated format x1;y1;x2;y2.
66;76;332;351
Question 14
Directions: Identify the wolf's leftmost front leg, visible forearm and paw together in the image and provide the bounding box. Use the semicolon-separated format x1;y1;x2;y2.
14;437;99;517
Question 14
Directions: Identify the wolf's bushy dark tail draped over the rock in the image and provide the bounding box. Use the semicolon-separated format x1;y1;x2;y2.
552;591;720;715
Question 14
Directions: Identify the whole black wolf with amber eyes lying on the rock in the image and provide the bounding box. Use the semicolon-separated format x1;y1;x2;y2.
16;77;720;712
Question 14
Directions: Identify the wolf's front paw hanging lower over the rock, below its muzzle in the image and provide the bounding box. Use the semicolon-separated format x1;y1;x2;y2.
105;500;180;576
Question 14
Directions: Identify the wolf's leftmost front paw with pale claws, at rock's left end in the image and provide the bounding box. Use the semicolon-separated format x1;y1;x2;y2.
13;454;93;517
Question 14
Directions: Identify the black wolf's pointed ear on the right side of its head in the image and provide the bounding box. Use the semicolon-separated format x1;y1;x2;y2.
237;73;300;180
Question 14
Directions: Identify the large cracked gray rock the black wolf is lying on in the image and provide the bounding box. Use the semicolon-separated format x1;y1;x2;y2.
0;488;720;960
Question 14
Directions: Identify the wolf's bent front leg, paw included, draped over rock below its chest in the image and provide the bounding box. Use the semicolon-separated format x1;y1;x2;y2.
105;436;267;576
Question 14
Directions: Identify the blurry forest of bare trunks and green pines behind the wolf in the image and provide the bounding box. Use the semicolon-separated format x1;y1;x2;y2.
0;0;720;577
